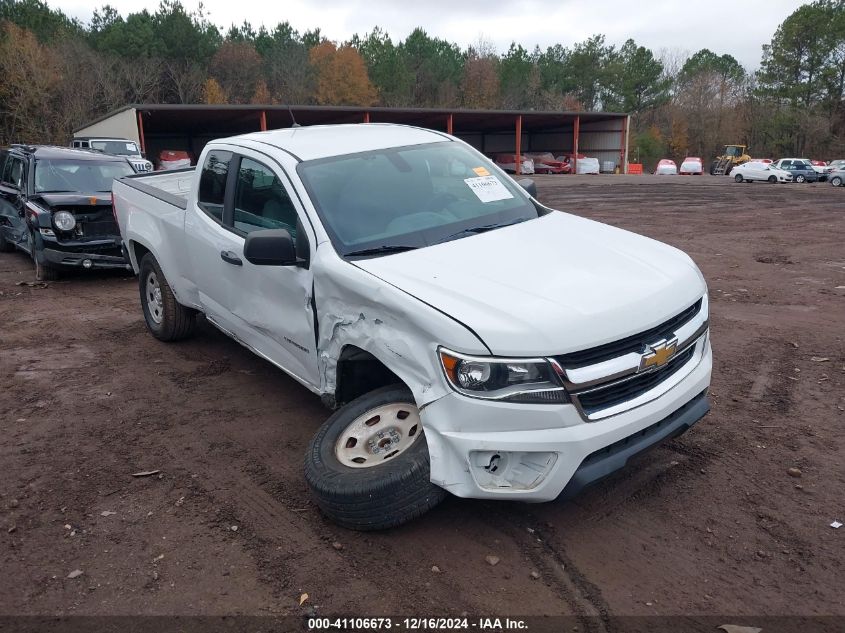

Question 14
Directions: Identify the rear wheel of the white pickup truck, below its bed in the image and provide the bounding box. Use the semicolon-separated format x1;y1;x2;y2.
138;253;196;342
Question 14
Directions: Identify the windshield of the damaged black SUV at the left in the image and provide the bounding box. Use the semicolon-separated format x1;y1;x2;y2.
35;159;135;193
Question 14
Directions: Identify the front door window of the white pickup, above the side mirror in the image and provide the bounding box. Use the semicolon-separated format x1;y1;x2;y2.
234;157;297;239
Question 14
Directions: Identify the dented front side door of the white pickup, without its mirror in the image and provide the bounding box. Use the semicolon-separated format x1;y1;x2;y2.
186;149;319;385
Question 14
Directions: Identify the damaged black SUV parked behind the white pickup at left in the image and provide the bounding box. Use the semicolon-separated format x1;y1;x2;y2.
0;145;135;280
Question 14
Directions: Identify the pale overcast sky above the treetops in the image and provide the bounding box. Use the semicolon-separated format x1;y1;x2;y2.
56;0;809;70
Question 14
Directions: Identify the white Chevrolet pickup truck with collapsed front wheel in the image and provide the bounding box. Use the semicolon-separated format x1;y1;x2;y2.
109;124;712;530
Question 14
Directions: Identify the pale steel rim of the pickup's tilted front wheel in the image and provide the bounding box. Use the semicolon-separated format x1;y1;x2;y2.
334;402;422;468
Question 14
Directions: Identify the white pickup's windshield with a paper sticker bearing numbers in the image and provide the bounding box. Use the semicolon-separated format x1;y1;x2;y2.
297;141;538;256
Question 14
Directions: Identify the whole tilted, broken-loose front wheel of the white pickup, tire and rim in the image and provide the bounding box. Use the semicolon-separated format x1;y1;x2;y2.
305;385;446;530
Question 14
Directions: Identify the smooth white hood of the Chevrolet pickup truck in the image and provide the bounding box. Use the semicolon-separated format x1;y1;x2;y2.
355;212;706;356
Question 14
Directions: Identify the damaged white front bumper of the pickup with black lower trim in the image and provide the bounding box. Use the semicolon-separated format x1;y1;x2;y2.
420;337;712;501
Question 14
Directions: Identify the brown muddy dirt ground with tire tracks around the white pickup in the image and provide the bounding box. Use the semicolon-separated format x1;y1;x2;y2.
0;176;845;619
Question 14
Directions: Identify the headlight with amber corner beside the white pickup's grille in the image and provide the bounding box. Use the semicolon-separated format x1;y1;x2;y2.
438;348;569;404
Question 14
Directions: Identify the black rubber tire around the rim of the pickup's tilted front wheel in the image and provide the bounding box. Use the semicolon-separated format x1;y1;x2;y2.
305;385;446;531
